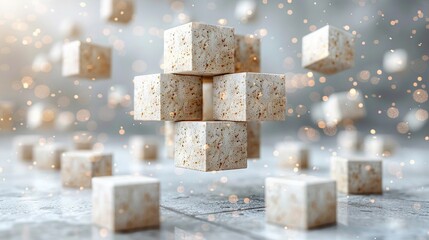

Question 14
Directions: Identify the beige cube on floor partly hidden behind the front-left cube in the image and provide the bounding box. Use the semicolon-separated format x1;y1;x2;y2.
61;150;112;188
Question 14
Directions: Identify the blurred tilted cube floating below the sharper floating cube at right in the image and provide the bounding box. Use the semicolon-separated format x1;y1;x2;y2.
323;91;366;126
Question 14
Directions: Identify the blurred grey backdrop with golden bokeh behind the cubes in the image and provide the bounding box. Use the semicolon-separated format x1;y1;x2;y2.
0;0;429;142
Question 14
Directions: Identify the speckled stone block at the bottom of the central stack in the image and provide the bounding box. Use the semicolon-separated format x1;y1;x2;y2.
174;121;247;171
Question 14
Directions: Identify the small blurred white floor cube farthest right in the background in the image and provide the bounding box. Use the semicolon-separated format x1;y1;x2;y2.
364;134;397;157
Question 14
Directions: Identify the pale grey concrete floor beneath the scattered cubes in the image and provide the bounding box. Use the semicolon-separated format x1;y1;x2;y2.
0;138;429;240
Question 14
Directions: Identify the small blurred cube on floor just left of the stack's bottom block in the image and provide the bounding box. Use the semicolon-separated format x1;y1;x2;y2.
129;136;158;160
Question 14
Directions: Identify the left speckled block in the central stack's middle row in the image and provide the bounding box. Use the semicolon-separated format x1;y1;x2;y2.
134;74;203;121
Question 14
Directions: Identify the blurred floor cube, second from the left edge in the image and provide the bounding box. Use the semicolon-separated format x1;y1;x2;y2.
33;144;67;169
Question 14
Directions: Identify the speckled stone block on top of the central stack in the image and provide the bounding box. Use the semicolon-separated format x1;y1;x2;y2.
164;22;235;76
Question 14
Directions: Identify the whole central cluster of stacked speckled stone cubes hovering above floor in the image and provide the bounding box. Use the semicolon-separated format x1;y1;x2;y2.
134;22;286;171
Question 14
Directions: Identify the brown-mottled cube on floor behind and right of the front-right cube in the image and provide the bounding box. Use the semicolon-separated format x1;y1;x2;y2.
331;156;383;194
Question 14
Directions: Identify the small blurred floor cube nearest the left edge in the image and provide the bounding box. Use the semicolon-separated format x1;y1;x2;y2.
13;135;41;161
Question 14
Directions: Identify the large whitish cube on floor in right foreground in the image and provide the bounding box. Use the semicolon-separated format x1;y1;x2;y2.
265;175;337;229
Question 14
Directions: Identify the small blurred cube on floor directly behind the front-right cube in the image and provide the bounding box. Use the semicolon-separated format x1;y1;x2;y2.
274;141;310;169
